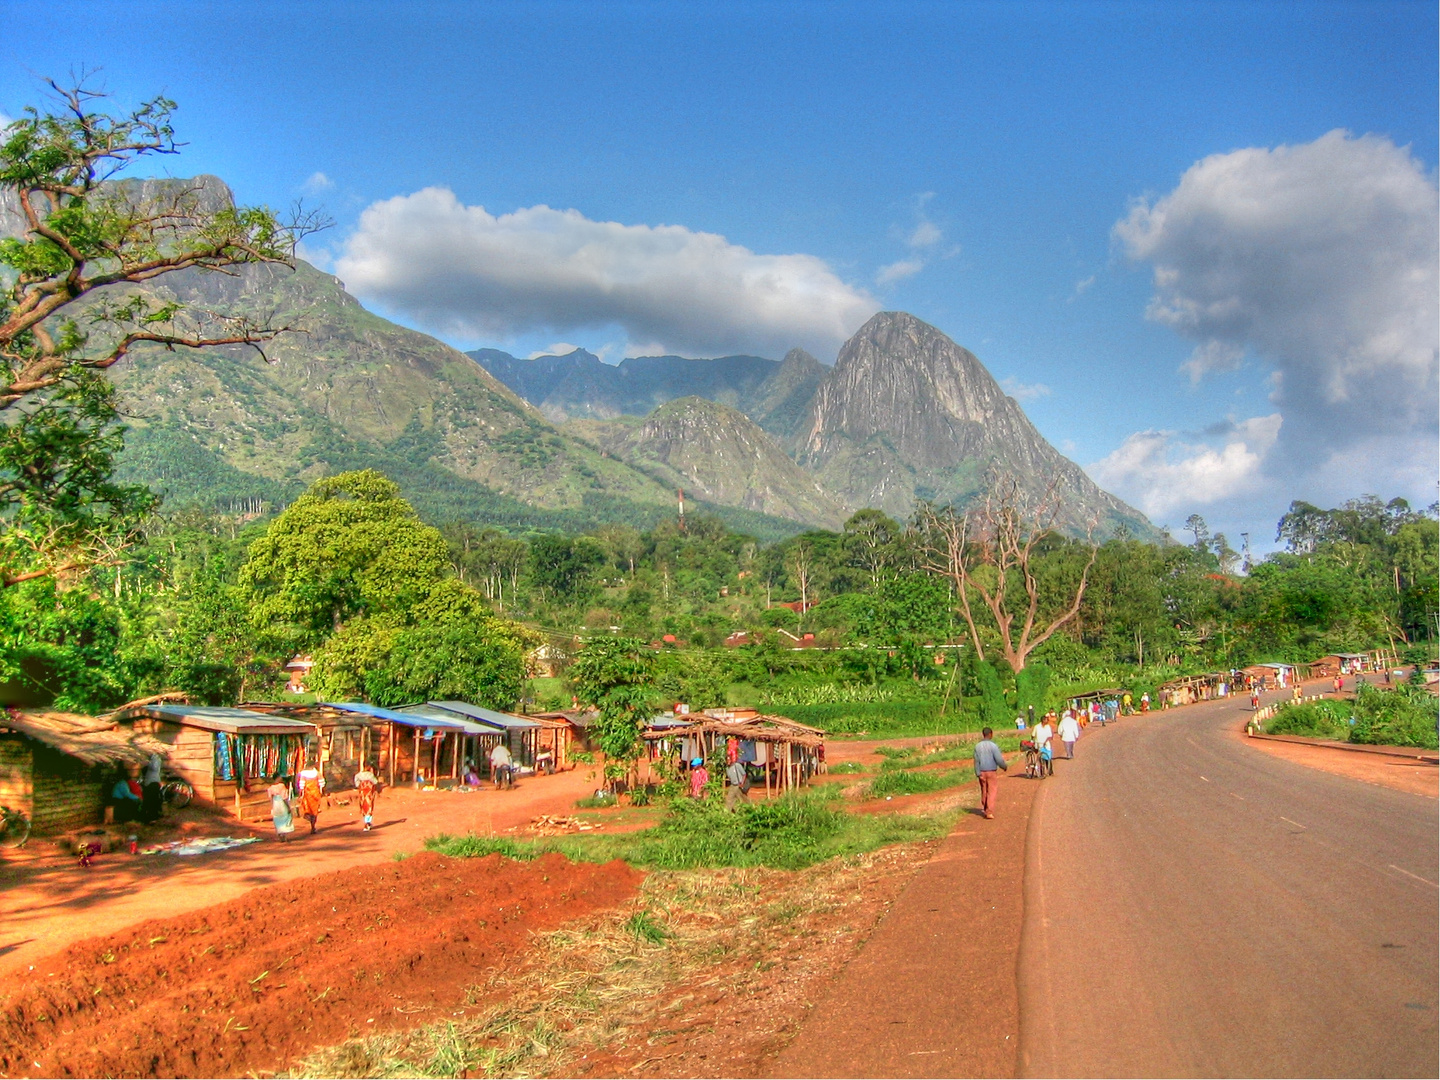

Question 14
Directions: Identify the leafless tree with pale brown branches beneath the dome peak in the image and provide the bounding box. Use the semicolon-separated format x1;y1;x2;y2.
913;478;1100;671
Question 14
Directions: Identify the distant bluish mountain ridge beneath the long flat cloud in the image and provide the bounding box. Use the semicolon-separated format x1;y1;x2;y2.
467;348;780;423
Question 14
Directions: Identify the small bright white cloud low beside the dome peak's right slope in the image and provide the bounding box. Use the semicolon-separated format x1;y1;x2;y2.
1086;413;1282;517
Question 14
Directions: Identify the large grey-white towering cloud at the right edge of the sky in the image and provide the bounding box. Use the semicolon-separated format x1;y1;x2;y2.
1106;131;1440;486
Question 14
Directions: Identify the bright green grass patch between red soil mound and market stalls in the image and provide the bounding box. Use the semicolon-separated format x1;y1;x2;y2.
425;789;962;870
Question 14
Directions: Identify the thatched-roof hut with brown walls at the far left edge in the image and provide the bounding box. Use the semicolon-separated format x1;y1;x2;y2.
0;708;163;834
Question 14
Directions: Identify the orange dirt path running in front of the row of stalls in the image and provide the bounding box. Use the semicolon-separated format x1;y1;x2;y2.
0;766;595;976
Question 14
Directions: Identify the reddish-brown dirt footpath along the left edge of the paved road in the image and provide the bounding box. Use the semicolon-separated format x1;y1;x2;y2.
766;763;1042;1077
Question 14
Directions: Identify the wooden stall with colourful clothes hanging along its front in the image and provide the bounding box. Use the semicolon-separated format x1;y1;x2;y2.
115;704;317;821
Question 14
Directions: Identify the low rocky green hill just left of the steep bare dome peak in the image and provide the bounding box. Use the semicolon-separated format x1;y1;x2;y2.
564;397;845;528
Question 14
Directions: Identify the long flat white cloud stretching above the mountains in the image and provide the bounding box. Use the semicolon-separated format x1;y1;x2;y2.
336;187;880;356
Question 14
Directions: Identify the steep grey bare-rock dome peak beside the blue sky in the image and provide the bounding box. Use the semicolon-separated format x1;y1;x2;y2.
796;311;1153;536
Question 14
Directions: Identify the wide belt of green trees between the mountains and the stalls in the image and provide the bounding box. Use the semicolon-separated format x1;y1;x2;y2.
0;471;1437;732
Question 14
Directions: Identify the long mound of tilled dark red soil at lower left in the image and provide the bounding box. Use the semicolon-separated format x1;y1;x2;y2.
0;852;642;1077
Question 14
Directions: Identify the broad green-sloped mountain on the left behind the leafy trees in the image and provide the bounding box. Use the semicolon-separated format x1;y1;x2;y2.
84;177;796;539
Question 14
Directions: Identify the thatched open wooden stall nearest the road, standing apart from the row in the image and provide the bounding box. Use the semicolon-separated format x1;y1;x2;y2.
642;713;825;795
